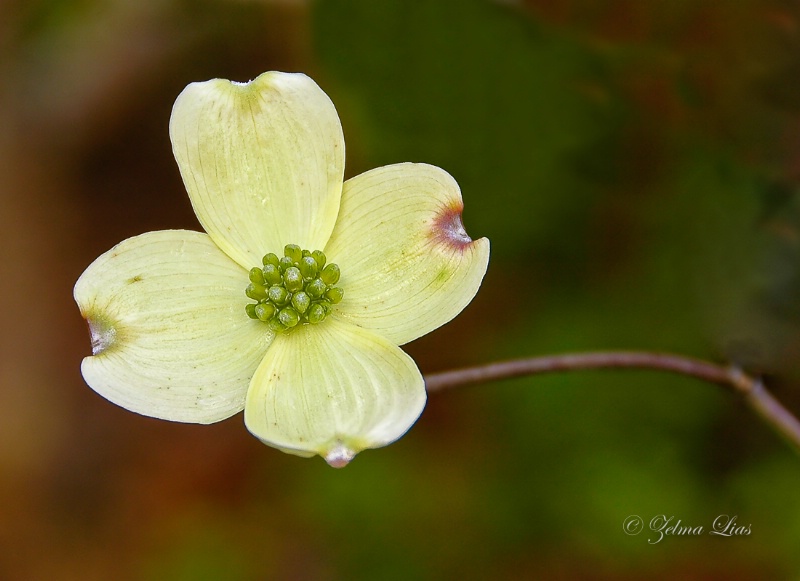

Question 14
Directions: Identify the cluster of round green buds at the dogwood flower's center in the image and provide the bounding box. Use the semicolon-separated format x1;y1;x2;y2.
244;244;344;332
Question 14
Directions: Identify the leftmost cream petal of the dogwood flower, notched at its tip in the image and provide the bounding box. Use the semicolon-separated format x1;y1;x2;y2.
74;230;273;424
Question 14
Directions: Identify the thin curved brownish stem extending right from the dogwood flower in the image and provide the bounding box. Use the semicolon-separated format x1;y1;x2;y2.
425;351;800;452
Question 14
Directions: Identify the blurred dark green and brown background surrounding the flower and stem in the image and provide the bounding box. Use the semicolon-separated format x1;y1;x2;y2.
0;0;800;580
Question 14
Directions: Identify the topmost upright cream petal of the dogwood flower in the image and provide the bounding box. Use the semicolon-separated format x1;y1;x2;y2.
170;72;344;268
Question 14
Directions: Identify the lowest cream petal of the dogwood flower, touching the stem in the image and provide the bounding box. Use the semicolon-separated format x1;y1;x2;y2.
244;318;425;467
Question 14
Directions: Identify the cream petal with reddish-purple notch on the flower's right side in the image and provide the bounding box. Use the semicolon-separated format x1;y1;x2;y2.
325;163;489;345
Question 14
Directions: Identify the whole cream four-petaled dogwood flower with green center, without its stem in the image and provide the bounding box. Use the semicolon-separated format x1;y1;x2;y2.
74;72;489;466
